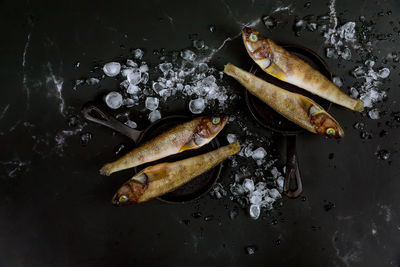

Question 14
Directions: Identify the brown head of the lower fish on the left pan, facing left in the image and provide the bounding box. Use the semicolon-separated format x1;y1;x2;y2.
111;173;148;207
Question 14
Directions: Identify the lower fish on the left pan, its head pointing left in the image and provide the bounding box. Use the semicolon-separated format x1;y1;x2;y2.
111;142;240;207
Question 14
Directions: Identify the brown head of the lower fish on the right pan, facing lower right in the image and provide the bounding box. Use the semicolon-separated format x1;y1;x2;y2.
309;106;344;139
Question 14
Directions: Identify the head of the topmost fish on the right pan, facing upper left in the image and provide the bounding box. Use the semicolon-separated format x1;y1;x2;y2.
242;27;272;64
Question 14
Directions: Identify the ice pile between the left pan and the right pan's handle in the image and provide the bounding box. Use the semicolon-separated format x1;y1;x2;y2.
210;129;284;219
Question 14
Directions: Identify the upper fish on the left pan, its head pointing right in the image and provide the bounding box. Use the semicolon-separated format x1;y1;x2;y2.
100;115;229;176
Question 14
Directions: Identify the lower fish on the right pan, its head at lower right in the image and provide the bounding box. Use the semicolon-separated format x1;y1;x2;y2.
224;63;344;138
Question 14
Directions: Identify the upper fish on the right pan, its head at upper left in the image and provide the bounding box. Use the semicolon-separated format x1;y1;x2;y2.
242;27;364;112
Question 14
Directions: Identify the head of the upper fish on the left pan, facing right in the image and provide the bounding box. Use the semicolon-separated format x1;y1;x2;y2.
194;115;229;146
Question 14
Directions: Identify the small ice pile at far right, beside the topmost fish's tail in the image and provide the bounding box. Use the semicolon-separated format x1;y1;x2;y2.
350;60;390;113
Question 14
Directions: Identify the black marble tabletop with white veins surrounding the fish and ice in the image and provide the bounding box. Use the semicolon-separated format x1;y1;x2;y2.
0;0;400;266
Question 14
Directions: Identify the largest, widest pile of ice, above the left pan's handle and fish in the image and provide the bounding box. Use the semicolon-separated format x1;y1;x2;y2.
98;47;230;122
